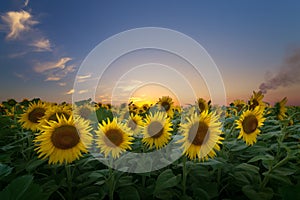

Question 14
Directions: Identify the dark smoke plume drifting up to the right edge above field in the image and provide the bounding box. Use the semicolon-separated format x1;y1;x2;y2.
259;49;300;93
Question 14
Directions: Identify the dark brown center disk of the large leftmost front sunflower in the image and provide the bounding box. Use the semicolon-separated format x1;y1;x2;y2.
51;126;80;149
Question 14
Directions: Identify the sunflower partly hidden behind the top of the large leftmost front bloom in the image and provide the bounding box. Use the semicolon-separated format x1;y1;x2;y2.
39;106;71;127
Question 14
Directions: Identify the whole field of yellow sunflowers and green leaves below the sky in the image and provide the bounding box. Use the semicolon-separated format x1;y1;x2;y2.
0;92;300;200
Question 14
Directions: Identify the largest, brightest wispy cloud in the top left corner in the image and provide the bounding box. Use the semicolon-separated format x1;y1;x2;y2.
1;10;38;39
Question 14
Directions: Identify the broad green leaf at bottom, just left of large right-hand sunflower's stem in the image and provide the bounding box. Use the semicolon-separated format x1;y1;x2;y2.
154;169;179;194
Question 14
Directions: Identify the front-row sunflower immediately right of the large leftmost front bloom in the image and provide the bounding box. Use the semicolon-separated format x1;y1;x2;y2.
96;118;134;158
